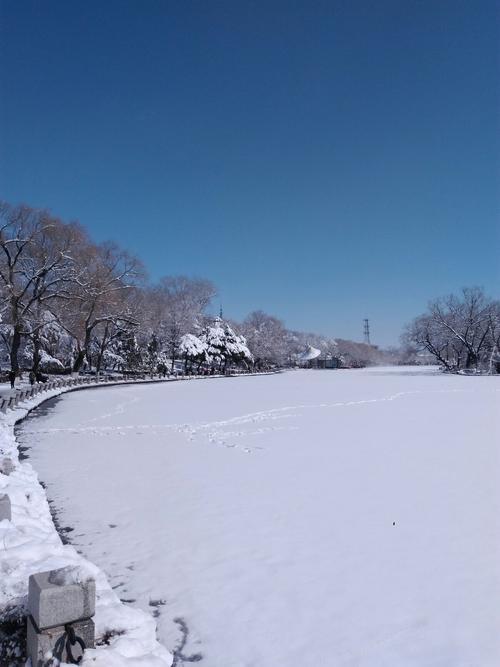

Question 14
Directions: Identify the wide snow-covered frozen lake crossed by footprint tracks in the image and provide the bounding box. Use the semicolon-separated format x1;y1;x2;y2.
19;368;500;667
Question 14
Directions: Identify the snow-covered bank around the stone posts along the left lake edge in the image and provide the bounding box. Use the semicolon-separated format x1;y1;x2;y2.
0;380;172;667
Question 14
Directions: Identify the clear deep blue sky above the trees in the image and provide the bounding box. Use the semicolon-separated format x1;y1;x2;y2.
0;0;500;344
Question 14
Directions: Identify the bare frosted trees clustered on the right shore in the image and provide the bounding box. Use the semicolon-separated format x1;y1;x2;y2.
402;287;500;373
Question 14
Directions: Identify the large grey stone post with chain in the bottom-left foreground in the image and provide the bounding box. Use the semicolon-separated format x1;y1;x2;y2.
27;567;95;667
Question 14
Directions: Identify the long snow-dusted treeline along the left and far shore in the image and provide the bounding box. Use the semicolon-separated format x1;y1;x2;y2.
0;202;399;373
